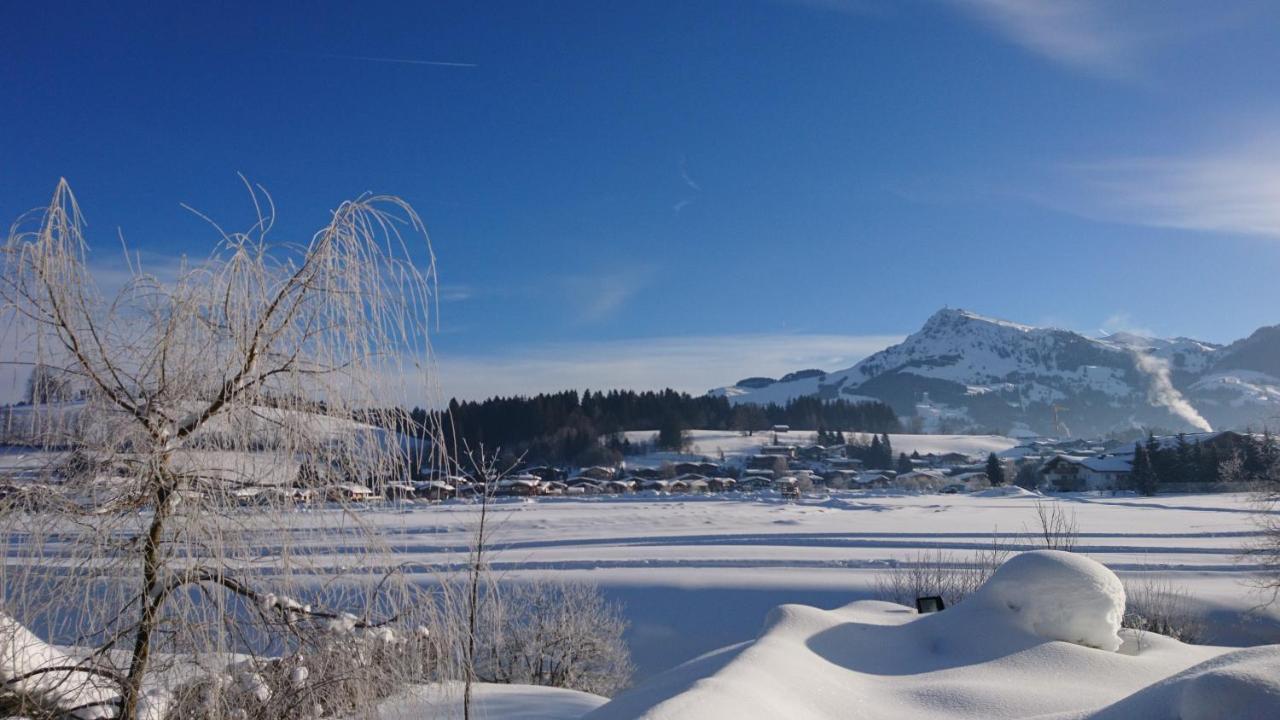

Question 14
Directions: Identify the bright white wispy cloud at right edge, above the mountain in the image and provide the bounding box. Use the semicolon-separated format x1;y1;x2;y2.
1048;135;1280;237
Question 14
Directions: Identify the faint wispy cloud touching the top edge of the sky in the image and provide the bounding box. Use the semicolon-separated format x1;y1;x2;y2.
951;0;1139;77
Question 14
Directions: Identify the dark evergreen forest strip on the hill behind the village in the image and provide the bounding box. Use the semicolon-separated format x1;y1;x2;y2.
413;389;900;464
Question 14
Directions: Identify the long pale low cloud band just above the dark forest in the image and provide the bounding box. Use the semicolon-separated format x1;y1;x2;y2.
436;334;902;400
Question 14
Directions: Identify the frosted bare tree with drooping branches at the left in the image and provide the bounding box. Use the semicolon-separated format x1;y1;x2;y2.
0;182;445;720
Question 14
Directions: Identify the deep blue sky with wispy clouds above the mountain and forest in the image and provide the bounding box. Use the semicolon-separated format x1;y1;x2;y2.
0;0;1280;397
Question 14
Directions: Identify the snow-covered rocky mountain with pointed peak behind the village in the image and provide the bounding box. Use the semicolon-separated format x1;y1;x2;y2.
712;309;1280;434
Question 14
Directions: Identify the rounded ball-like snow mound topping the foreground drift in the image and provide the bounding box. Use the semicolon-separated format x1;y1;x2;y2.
964;550;1124;652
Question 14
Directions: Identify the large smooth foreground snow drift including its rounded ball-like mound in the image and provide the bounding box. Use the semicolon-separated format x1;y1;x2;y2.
586;551;1280;720
